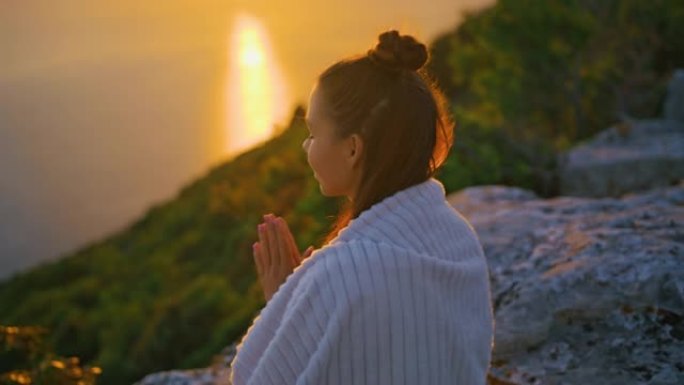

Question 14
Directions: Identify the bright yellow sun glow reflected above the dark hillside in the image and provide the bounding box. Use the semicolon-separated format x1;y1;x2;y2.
225;13;288;155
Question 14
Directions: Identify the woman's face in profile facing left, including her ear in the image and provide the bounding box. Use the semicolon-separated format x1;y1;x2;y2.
302;86;362;199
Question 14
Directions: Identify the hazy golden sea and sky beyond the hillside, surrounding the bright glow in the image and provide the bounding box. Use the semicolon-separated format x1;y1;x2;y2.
0;0;492;279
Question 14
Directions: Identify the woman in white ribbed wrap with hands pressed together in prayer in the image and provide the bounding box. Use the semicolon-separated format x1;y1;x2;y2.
231;30;494;385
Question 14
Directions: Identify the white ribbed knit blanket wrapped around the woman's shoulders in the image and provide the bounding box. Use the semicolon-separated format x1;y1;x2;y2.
231;178;494;385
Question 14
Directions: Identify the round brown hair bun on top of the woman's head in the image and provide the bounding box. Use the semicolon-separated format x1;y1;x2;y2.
368;30;428;71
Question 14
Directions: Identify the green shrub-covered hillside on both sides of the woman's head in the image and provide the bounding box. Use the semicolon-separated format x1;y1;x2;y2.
0;0;684;385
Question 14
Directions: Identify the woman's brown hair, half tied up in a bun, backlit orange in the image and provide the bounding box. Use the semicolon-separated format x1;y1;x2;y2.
317;30;454;243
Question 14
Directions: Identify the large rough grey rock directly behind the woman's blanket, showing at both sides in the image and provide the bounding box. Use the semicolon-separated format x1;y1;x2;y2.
136;180;684;385
